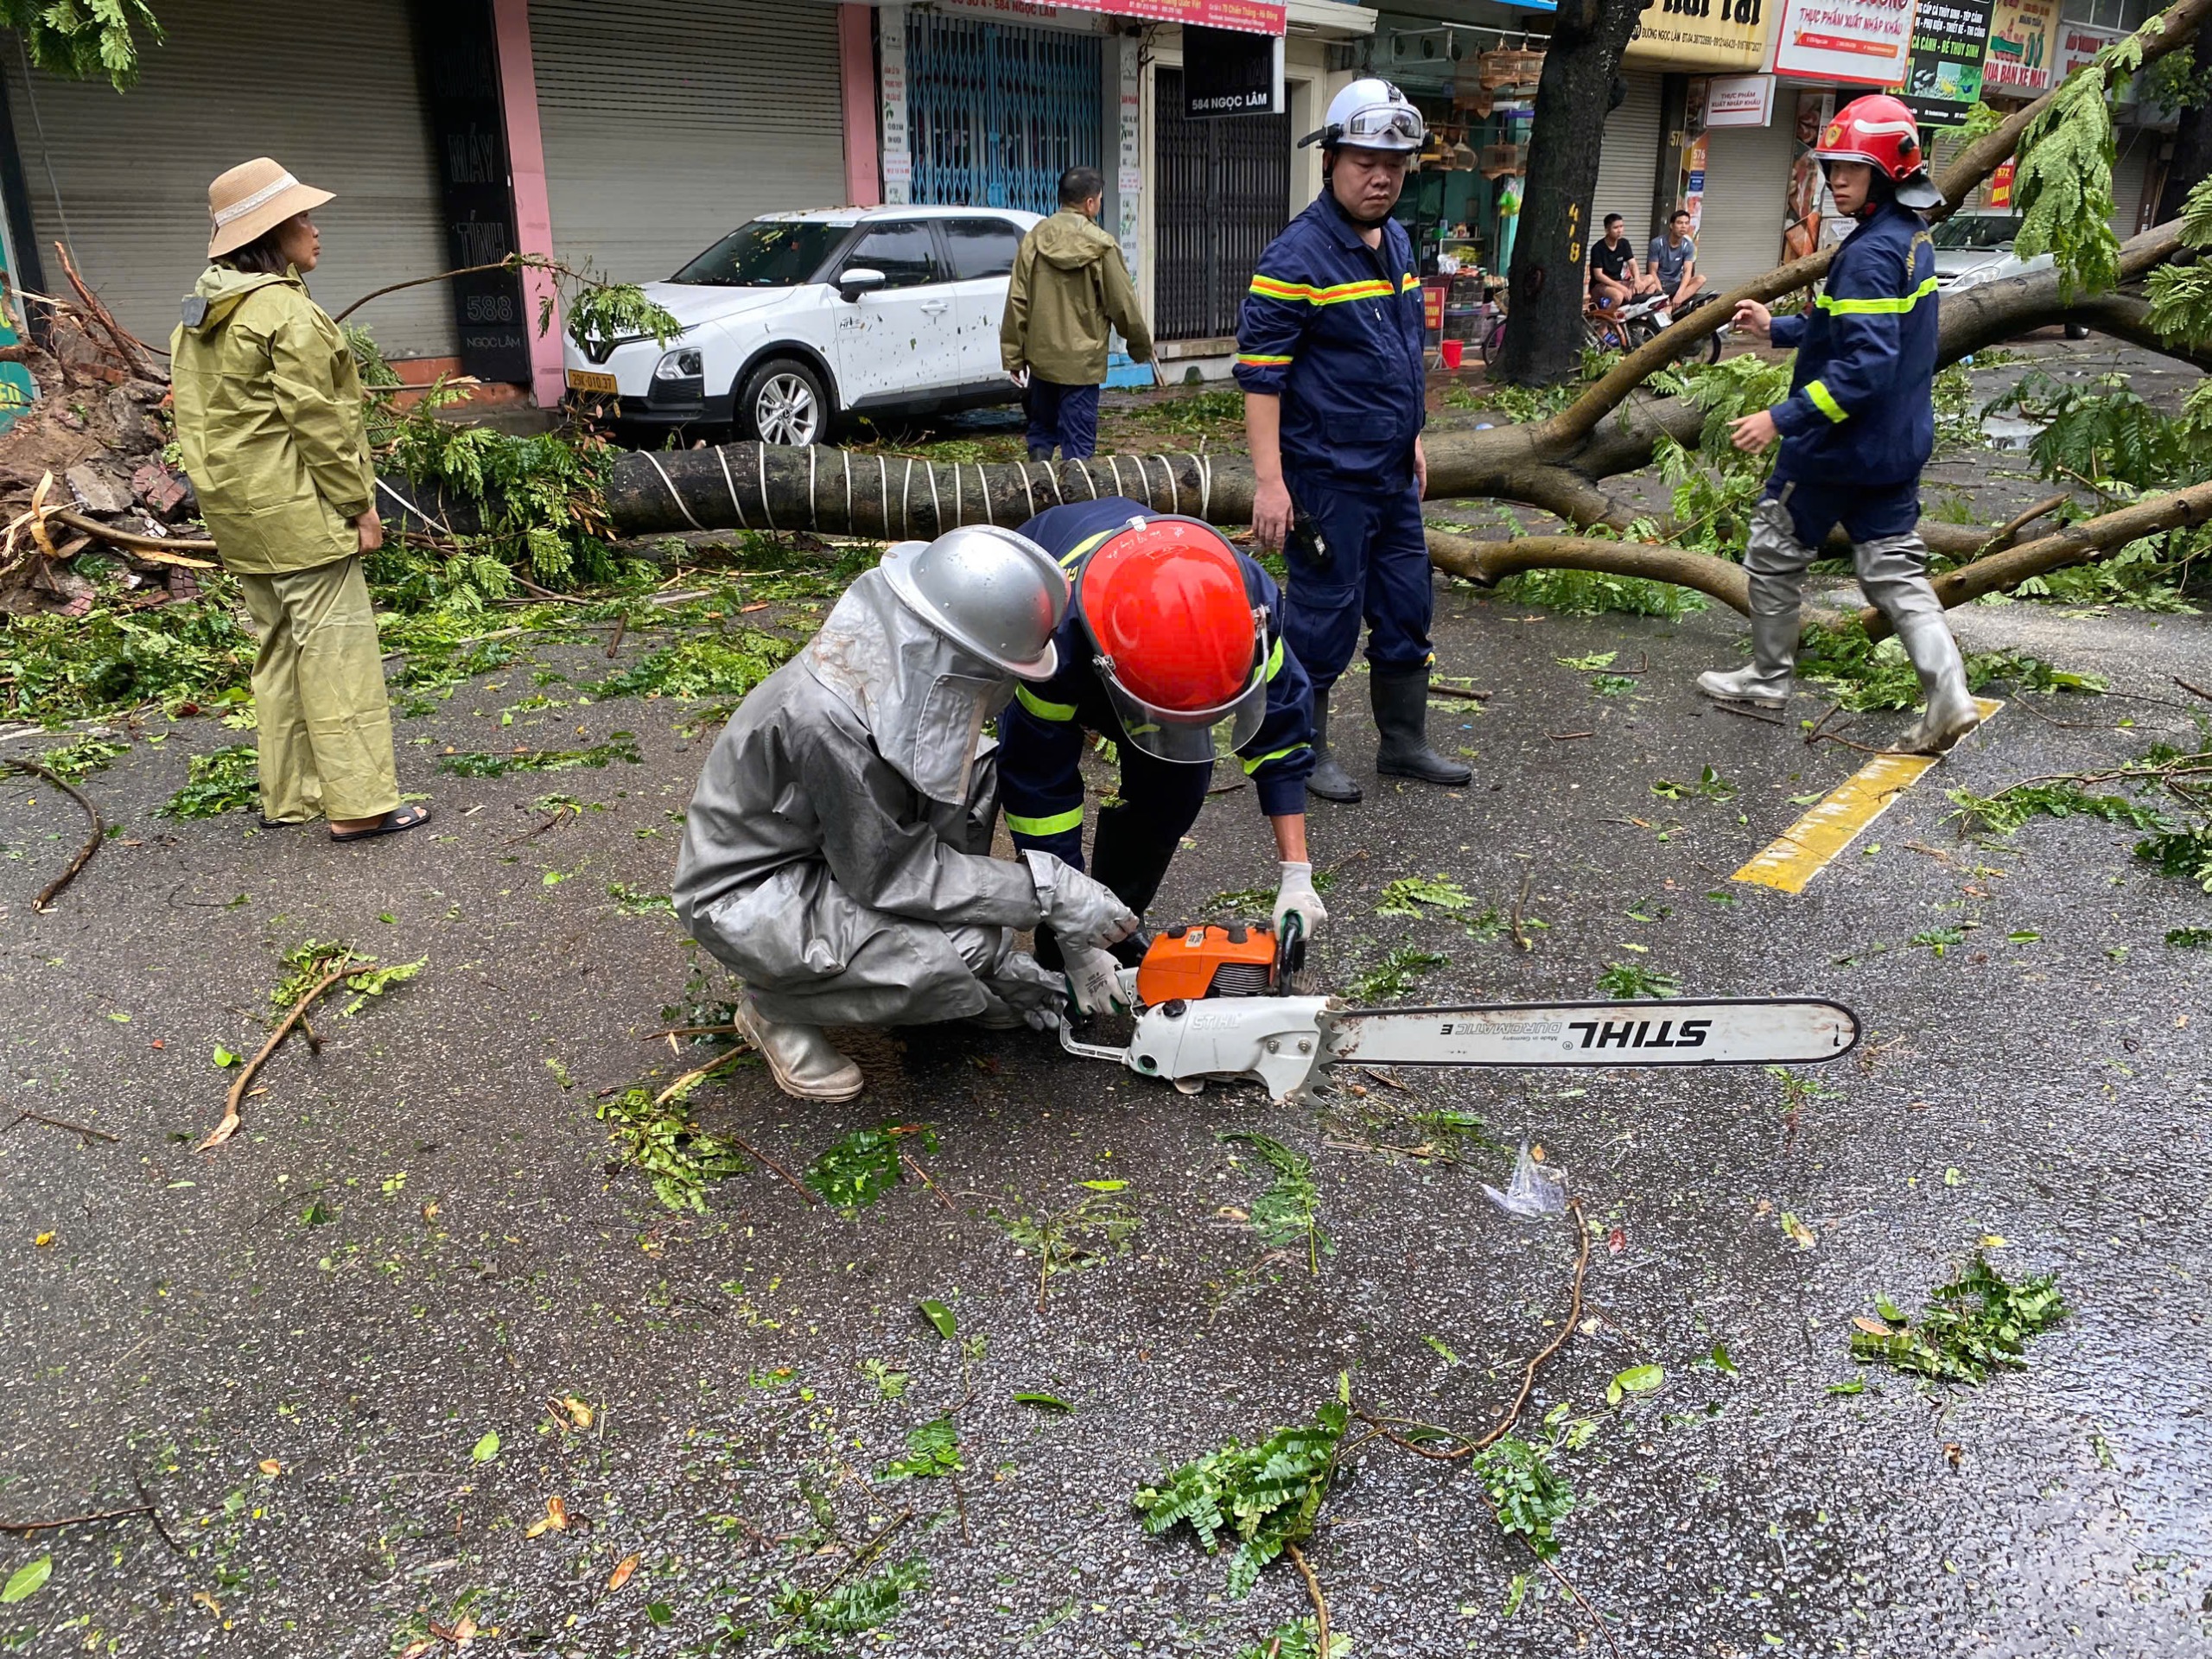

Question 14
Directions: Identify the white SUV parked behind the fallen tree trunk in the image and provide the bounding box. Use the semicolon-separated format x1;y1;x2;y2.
564;208;1038;445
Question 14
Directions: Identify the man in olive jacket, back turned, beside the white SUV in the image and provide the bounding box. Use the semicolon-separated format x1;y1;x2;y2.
998;168;1153;460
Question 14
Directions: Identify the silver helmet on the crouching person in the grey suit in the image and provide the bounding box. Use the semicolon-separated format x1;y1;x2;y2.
882;524;1068;681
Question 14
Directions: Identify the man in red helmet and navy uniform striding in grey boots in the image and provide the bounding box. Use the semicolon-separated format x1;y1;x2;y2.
1697;95;1982;754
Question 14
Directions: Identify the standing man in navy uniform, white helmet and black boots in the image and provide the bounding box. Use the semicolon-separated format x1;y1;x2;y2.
1236;79;1471;801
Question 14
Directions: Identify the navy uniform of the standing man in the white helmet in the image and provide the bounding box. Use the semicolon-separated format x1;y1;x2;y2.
1236;190;1435;696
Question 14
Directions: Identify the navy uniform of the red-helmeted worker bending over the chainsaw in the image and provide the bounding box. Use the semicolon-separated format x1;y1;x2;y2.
998;495;1314;967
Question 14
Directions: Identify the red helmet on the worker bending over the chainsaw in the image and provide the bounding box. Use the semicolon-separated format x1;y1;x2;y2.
1075;518;1268;766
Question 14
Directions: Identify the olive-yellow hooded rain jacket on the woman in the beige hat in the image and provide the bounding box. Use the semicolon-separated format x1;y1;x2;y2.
168;265;376;575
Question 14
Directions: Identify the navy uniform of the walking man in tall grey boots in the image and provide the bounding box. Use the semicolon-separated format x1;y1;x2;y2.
1767;201;1936;546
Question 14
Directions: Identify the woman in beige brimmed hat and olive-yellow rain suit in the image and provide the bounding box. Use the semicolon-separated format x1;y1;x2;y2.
170;157;429;841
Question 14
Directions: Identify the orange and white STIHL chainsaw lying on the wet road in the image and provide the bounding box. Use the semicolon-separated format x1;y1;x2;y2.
1059;918;1858;1103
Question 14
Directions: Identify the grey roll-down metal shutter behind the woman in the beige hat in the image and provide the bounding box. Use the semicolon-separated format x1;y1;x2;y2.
0;0;458;356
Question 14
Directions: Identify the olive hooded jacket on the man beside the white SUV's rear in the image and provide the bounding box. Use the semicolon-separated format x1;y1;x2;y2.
998;208;1153;385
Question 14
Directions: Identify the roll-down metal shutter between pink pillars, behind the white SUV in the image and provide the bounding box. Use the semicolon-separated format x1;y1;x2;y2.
531;0;845;283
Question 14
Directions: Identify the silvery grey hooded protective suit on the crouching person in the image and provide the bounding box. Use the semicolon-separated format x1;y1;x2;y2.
675;570;1042;1027
